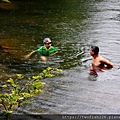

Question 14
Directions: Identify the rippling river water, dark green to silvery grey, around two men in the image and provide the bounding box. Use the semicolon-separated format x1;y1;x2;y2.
0;0;120;114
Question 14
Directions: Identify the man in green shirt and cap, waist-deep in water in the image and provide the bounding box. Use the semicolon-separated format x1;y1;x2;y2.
25;38;57;61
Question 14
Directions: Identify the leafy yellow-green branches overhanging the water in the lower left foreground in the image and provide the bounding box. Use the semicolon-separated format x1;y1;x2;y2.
0;68;61;115
